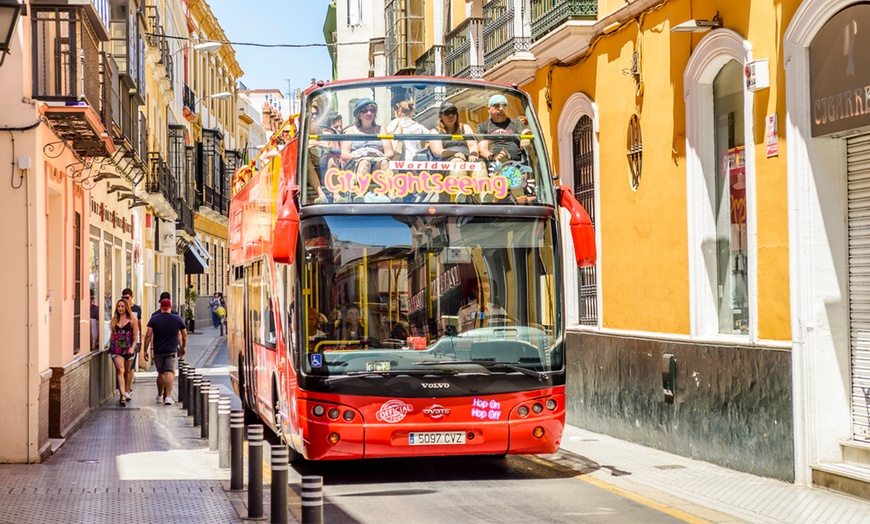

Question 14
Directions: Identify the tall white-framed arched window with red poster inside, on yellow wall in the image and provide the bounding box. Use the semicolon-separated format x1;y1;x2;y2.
685;30;758;339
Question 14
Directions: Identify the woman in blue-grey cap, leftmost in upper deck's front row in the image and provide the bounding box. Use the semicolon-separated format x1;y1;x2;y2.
341;97;393;201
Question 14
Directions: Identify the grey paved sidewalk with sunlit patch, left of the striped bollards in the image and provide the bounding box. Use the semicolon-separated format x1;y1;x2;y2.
0;328;252;524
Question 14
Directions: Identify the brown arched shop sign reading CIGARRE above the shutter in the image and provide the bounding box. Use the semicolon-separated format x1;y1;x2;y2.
810;4;870;136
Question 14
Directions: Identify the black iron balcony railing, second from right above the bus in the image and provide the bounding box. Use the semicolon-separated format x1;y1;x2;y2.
483;0;532;69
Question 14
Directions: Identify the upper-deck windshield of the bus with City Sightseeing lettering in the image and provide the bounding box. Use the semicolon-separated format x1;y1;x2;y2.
298;78;554;206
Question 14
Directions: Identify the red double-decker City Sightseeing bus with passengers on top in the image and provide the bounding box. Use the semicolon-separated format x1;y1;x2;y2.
228;77;595;460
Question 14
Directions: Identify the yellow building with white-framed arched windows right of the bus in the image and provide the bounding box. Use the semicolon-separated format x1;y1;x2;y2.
334;0;870;494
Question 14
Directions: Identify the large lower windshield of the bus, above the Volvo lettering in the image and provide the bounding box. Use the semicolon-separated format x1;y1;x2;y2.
301;215;563;376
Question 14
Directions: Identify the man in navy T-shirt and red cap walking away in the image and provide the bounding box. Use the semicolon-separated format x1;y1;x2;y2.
142;298;187;405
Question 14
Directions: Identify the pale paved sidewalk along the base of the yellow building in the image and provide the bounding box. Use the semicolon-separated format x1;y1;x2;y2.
560;426;870;524
